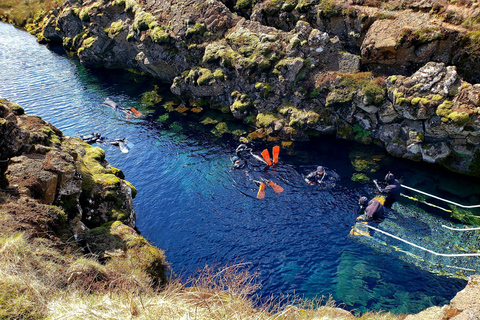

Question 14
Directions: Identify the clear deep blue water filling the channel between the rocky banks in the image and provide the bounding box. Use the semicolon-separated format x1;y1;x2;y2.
0;23;479;313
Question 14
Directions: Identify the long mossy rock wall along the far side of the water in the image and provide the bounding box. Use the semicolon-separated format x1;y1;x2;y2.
23;0;480;176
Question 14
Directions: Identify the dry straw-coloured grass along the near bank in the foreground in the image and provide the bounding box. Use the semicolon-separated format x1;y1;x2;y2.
0;233;403;320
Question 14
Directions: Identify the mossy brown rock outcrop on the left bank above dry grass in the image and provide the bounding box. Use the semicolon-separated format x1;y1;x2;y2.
0;99;167;283
